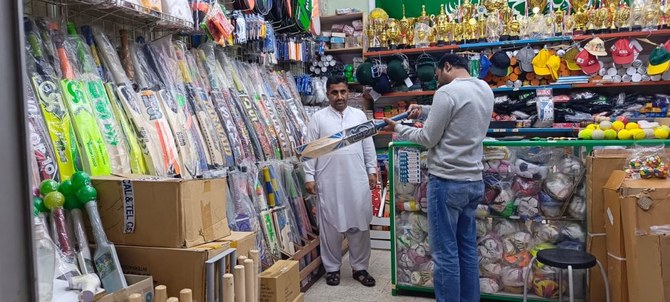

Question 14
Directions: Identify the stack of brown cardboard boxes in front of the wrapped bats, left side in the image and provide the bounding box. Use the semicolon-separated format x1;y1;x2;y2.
89;175;266;302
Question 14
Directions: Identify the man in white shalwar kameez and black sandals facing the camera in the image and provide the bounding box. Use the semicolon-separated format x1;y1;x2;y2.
305;78;377;286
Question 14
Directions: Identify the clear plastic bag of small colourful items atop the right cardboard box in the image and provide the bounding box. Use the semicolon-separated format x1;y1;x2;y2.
623;144;670;179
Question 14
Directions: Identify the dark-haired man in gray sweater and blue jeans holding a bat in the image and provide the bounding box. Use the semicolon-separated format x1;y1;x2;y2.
385;54;494;302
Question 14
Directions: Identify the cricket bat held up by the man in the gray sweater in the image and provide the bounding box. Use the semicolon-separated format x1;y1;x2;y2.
296;112;409;162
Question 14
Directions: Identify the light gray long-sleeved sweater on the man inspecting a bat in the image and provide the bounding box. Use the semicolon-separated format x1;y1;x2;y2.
395;78;494;181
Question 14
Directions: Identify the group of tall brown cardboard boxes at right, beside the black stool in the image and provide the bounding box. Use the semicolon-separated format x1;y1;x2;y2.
587;150;670;302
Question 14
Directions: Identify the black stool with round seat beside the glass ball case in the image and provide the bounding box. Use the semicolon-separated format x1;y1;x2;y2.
523;249;610;302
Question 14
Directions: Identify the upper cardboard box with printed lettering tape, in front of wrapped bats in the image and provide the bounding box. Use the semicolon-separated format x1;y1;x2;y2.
90;175;230;248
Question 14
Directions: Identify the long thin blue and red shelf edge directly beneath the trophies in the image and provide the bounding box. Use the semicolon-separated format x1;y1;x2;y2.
363;29;670;57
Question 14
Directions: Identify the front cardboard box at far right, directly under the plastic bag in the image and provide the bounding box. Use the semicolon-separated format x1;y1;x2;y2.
604;171;670;302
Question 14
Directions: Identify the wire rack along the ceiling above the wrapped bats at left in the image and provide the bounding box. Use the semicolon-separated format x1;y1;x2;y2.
31;0;194;32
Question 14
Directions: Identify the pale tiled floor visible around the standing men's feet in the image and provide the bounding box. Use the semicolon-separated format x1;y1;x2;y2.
305;250;435;302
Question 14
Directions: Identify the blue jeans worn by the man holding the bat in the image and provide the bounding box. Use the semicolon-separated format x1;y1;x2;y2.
428;175;484;302
